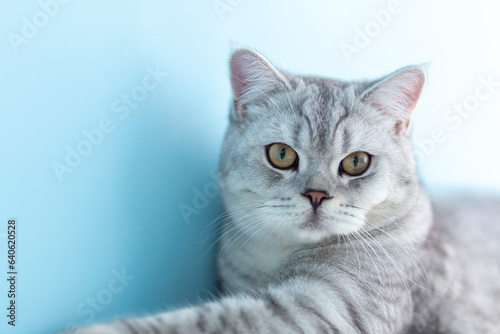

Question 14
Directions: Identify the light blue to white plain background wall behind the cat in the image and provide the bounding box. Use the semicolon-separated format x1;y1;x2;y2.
0;0;500;334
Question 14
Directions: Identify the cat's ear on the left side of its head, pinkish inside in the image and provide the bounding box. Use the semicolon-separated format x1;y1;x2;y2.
230;47;290;119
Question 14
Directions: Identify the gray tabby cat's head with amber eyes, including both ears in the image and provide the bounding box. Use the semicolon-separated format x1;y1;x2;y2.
219;48;425;242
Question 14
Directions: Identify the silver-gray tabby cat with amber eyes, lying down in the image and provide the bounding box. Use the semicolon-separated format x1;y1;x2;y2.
74;48;500;334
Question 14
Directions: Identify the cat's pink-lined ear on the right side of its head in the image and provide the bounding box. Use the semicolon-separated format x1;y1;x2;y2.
361;65;425;134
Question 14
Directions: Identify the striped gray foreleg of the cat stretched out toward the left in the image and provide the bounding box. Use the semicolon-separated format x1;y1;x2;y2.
71;277;403;334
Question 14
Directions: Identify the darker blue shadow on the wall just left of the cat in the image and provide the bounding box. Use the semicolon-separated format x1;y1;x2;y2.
56;98;223;332
